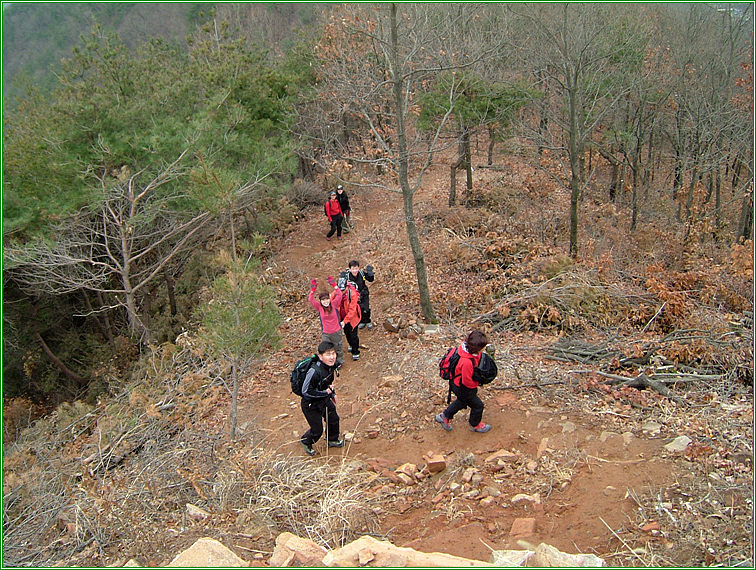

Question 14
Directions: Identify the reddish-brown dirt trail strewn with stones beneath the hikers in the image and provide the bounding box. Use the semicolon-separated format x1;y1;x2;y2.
239;166;674;565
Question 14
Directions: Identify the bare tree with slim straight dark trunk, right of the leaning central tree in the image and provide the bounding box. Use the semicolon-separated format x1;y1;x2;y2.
510;3;637;257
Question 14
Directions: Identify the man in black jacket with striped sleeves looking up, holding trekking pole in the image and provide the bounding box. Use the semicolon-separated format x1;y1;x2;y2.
299;342;344;455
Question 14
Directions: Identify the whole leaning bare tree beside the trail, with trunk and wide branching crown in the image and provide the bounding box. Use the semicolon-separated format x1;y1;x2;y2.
299;4;504;322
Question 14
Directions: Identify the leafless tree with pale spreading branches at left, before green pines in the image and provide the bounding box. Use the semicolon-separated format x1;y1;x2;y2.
4;151;212;342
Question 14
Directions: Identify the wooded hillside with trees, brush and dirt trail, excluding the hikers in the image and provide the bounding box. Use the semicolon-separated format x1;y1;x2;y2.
2;4;753;567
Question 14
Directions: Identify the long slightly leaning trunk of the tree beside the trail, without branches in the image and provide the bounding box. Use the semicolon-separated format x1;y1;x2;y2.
390;3;436;323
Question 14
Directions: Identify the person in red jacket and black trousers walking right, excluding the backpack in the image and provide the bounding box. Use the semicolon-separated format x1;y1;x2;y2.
434;330;491;433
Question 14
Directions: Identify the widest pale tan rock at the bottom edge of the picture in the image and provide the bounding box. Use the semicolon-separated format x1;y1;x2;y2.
323;536;492;568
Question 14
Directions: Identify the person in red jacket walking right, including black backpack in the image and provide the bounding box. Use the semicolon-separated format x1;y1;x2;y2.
434;330;497;433
